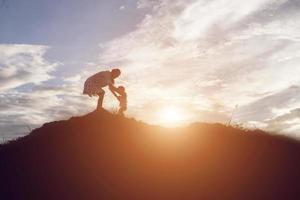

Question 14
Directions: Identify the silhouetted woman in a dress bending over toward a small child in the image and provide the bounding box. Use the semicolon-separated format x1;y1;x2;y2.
83;69;121;110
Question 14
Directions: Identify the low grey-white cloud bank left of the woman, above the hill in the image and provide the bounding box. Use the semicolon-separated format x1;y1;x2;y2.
0;85;95;139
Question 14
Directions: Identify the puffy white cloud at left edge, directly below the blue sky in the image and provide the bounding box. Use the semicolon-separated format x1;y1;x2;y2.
0;44;58;91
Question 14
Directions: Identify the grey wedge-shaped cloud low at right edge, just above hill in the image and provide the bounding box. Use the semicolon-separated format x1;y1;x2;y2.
235;86;300;137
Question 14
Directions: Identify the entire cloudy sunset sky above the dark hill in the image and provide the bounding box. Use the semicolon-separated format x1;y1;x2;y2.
0;0;300;140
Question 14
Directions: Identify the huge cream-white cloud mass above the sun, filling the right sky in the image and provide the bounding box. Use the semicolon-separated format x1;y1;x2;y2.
100;0;300;138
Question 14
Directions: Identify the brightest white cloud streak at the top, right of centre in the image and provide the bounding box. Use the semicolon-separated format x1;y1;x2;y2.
174;0;273;40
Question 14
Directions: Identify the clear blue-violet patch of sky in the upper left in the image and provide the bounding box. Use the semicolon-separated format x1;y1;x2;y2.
0;0;147;73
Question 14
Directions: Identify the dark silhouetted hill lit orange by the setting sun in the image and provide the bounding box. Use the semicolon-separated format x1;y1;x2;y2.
0;111;300;200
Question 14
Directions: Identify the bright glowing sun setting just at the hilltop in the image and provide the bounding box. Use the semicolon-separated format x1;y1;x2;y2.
160;106;184;126
